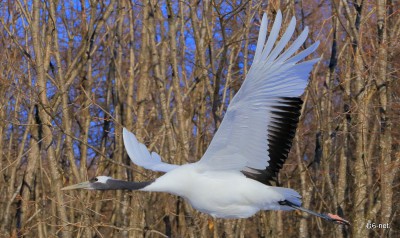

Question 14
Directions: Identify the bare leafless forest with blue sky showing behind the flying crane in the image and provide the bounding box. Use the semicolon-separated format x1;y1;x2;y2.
0;0;400;237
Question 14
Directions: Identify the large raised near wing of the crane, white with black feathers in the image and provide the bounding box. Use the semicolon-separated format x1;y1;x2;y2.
197;11;319;184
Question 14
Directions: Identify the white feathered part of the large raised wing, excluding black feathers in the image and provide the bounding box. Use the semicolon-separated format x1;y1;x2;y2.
197;11;319;170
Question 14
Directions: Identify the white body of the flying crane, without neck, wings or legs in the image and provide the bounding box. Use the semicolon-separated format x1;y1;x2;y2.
142;163;301;218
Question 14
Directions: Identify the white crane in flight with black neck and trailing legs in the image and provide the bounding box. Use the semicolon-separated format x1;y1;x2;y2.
63;11;349;225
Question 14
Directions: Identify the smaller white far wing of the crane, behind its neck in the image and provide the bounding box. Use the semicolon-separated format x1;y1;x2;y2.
122;128;179;172
